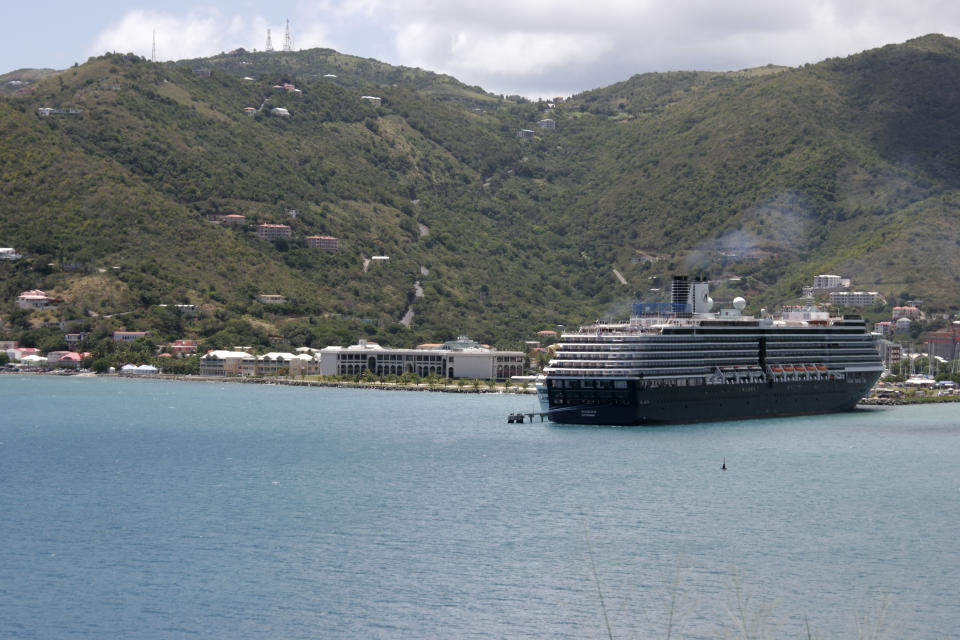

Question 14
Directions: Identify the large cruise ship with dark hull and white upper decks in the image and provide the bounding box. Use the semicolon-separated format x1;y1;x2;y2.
544;276;883;425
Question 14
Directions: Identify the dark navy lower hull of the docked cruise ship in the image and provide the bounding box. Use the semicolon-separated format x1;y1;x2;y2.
549;372;879;426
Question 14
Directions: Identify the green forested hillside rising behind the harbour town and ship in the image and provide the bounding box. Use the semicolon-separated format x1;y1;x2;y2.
0;36;960;356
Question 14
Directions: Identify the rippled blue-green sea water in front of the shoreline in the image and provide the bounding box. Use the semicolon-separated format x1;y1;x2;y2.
0;375;960;639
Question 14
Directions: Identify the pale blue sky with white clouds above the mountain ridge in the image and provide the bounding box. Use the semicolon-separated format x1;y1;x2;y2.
0;0;960;98
